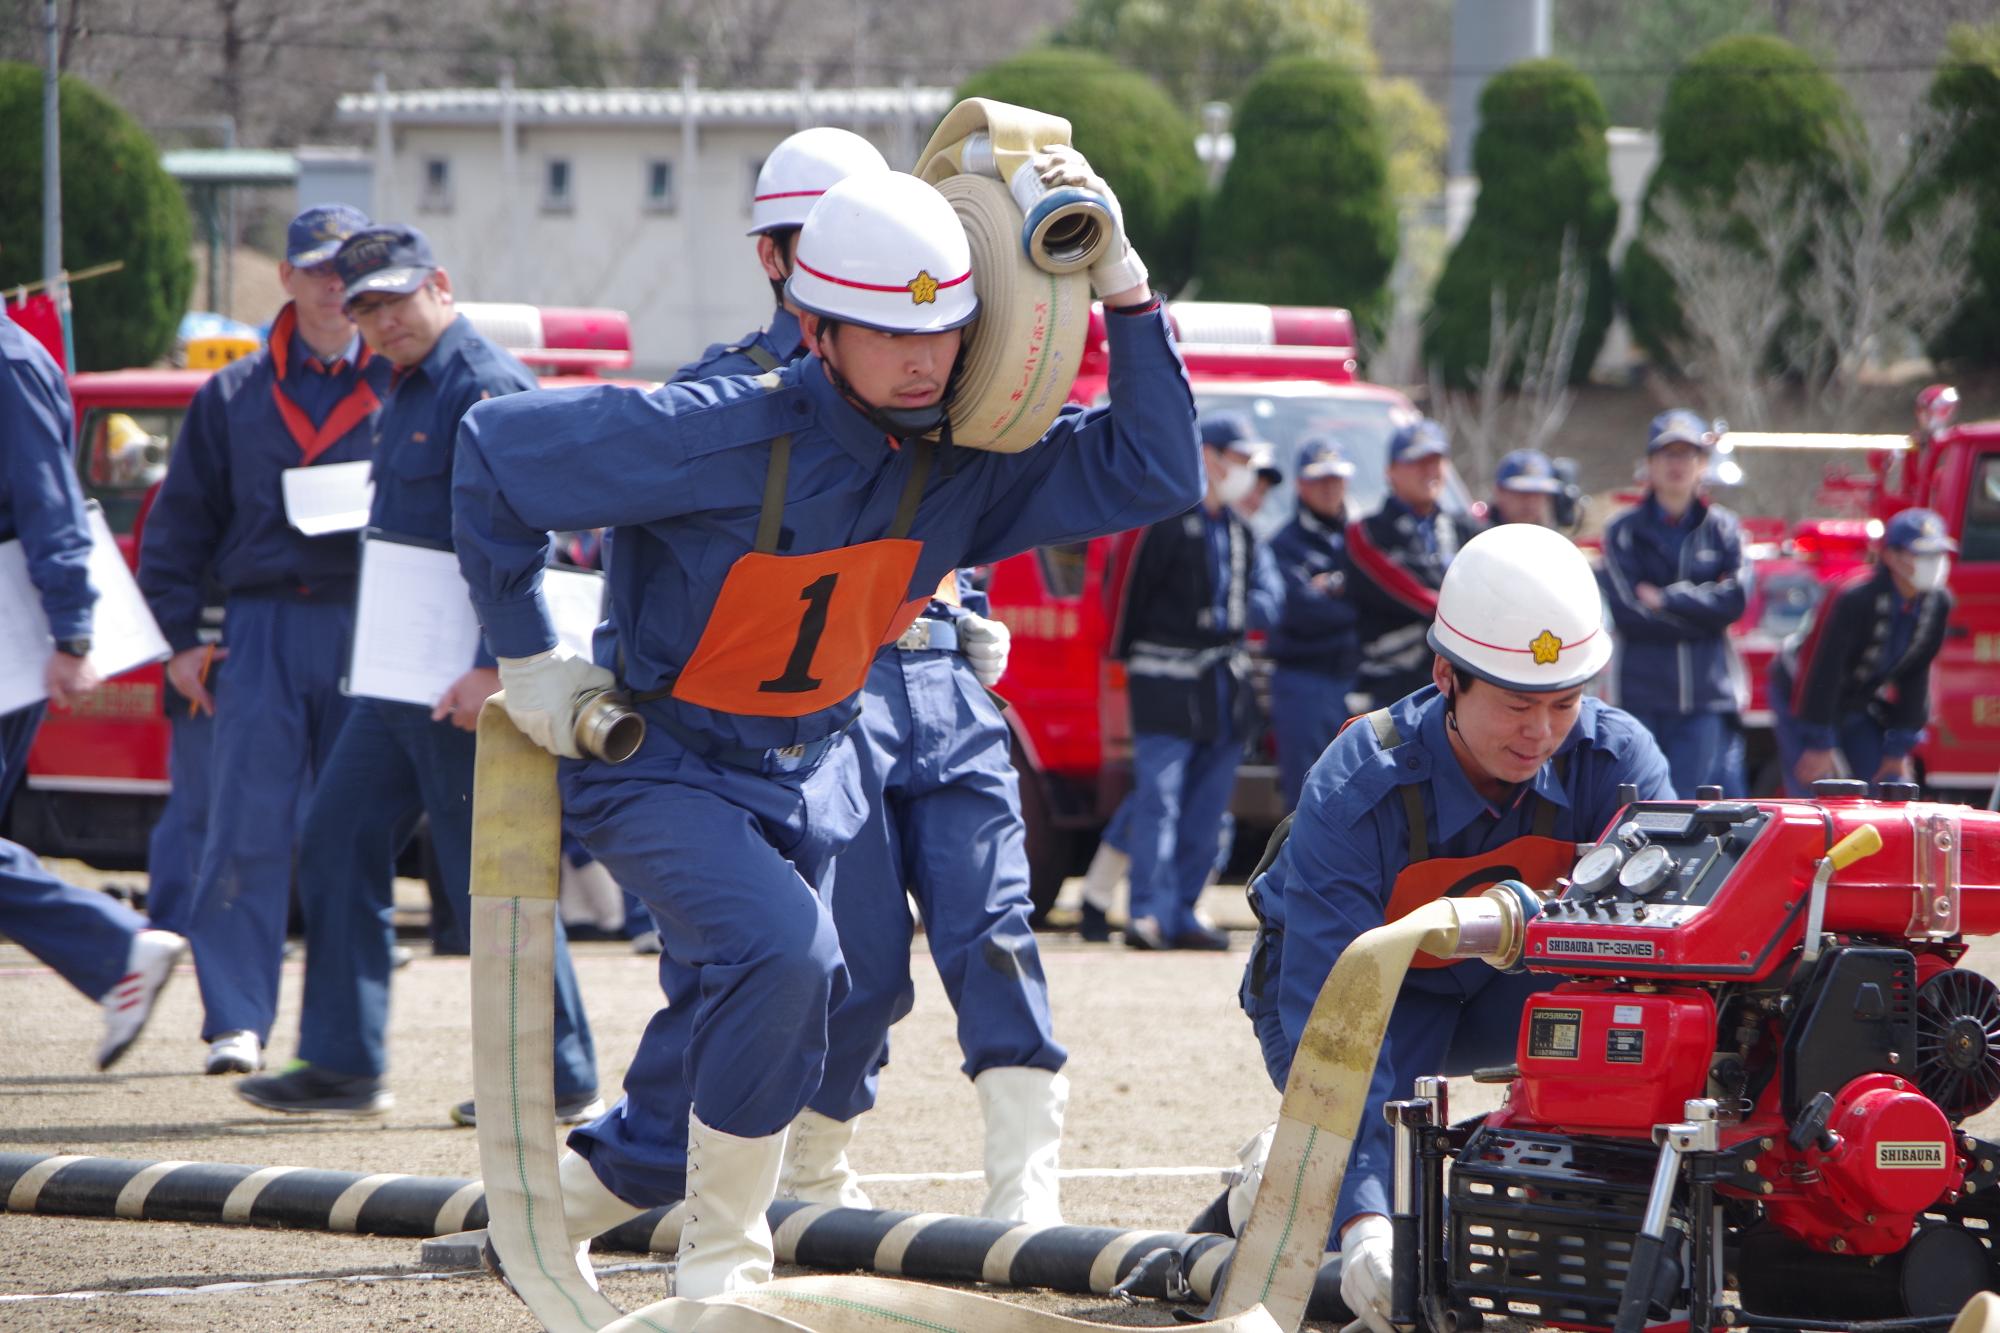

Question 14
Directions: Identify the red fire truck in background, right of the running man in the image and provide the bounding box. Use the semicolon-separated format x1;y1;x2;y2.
988;302;1468;911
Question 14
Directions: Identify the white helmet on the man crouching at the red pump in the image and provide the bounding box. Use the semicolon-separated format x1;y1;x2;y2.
1430;522;1612;695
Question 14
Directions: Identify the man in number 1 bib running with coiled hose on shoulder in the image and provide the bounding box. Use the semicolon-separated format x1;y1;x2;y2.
454;137;1200;1297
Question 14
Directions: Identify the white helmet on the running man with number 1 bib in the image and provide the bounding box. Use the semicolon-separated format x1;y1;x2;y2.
784;172;980;332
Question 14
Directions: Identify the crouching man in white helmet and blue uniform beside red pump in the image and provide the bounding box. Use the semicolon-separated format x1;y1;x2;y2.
1196;524;1674;1333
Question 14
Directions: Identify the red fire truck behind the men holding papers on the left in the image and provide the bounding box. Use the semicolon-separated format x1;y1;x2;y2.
0;302;632;871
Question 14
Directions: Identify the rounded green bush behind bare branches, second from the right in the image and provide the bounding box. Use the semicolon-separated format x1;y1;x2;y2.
1618;34;1858;366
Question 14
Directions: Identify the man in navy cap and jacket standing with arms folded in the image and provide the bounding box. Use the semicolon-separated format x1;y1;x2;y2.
1600;408;1746;799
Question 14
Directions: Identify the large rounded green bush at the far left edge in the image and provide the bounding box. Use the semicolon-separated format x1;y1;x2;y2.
0;62;194;370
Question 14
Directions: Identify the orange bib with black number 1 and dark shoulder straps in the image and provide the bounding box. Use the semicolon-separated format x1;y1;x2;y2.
672;426;930;717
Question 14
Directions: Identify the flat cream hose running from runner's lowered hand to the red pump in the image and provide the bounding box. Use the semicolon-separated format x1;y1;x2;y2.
472;695;1528;1333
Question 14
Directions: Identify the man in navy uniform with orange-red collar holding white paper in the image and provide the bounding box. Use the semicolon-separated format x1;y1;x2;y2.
138;204;388;1073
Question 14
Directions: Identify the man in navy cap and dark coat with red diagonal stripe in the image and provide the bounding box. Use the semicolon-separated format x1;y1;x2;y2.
1346;418;1472;709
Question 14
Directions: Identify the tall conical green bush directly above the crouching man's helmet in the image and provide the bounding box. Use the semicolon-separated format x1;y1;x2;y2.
1424;60;1618;384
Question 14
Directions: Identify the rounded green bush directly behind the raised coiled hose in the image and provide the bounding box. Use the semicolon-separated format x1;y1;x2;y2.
956;50;1206;294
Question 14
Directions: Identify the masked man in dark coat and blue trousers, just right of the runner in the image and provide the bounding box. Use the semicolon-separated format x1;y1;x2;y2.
1114;412;1284;949
